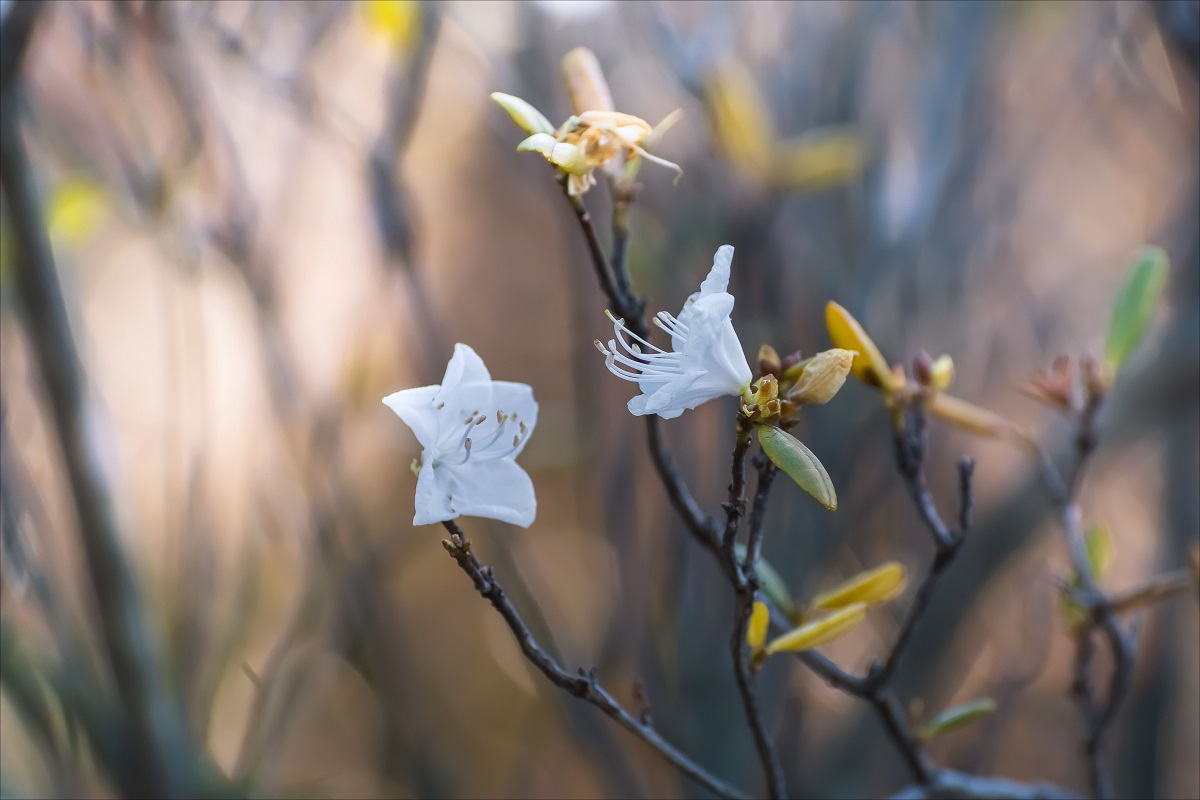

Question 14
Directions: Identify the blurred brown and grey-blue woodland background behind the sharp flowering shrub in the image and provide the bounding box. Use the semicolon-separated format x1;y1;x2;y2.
0;0;1200;798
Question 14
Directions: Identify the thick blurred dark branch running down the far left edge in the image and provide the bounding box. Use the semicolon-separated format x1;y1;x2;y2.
0;21;192;796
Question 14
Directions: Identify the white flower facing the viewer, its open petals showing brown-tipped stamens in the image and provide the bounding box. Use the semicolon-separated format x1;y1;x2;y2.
383;344;538;528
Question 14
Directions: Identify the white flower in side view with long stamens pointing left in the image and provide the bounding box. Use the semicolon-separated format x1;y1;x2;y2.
595;245;752;420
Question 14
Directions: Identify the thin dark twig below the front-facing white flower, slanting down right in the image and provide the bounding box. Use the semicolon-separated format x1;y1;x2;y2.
442;521;749;800
